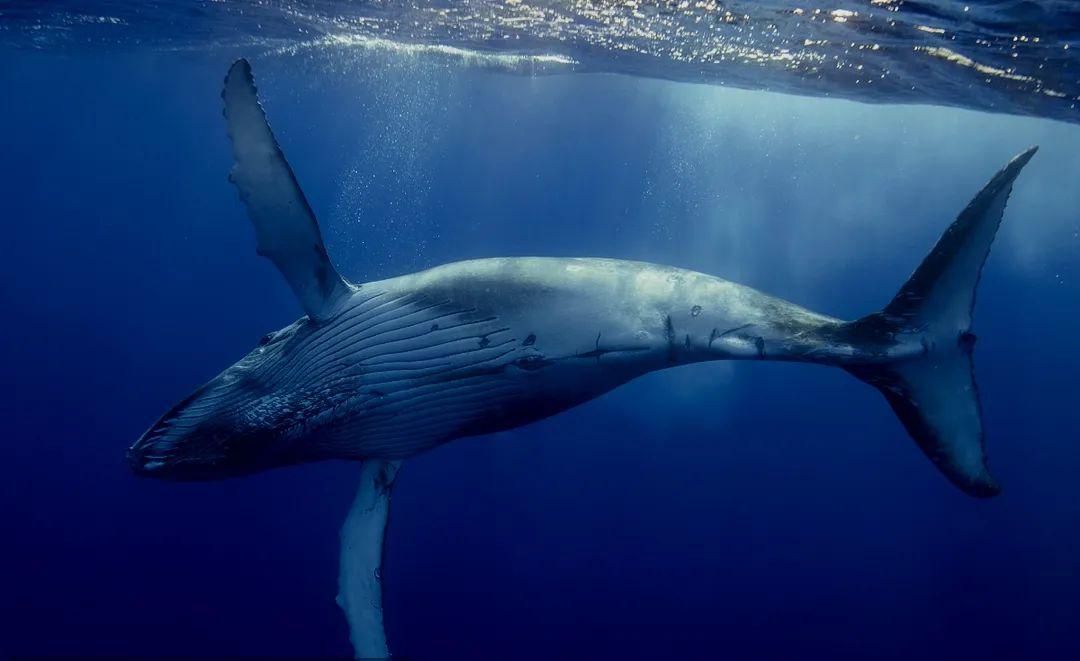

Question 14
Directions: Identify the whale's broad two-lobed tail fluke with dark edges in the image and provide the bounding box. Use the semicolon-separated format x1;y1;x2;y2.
848;147;1038;497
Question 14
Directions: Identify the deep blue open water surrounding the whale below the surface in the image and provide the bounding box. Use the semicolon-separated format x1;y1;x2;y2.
0;38;1080;659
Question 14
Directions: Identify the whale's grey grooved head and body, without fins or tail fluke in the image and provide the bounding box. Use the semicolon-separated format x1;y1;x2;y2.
130;257;922;478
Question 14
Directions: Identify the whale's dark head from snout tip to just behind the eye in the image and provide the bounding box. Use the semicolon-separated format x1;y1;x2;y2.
127;321;321;480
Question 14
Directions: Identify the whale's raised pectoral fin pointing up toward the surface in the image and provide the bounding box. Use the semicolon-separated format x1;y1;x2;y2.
221;59;351;321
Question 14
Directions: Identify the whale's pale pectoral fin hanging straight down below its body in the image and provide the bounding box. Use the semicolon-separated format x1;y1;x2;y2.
337;459;401;659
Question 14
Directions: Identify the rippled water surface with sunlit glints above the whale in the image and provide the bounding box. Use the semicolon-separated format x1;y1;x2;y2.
6;0;1080;122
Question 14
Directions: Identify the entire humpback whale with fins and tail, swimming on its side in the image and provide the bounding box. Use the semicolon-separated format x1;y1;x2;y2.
127;59;1037;657
